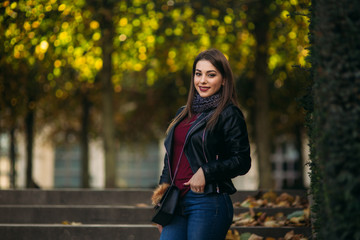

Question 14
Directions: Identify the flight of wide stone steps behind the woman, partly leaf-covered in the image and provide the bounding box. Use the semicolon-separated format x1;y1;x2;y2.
0;189;311;240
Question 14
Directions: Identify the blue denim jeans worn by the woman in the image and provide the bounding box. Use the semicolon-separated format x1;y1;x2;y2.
160;190;234;240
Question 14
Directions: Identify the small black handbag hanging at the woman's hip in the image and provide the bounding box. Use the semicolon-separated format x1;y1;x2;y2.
151;184;180;226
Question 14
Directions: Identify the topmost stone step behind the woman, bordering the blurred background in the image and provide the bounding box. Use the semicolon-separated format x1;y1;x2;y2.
0;189;307;205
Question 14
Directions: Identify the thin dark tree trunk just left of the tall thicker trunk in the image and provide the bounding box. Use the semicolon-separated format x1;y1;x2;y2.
80;93;90;188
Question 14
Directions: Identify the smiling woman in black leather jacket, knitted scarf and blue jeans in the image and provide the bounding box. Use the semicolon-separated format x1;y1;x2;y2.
153;49;251;240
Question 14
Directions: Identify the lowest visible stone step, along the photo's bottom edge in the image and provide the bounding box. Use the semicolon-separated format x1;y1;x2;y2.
0;224;311;240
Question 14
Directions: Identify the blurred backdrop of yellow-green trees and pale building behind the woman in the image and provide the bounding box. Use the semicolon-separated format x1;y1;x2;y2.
0;0;310;190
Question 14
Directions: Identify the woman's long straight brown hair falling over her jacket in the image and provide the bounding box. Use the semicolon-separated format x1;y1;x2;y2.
166;49;238;133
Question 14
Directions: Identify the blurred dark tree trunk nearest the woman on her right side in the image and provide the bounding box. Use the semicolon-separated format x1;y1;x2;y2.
254;0;274;189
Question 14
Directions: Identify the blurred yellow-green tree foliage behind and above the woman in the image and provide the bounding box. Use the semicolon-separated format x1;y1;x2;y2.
0;0;309;142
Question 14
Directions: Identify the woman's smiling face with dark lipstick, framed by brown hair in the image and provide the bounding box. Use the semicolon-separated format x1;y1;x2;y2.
194;60;224;98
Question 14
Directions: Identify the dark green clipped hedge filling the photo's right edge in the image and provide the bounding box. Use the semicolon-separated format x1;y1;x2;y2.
308;0;360;239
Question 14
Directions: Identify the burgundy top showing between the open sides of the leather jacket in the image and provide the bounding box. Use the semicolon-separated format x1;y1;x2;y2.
171;114;197;196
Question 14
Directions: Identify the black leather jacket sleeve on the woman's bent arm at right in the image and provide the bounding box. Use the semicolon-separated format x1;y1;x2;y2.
201;106;251;182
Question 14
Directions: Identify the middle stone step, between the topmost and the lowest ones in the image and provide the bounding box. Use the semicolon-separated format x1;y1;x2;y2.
0;205;301;224
